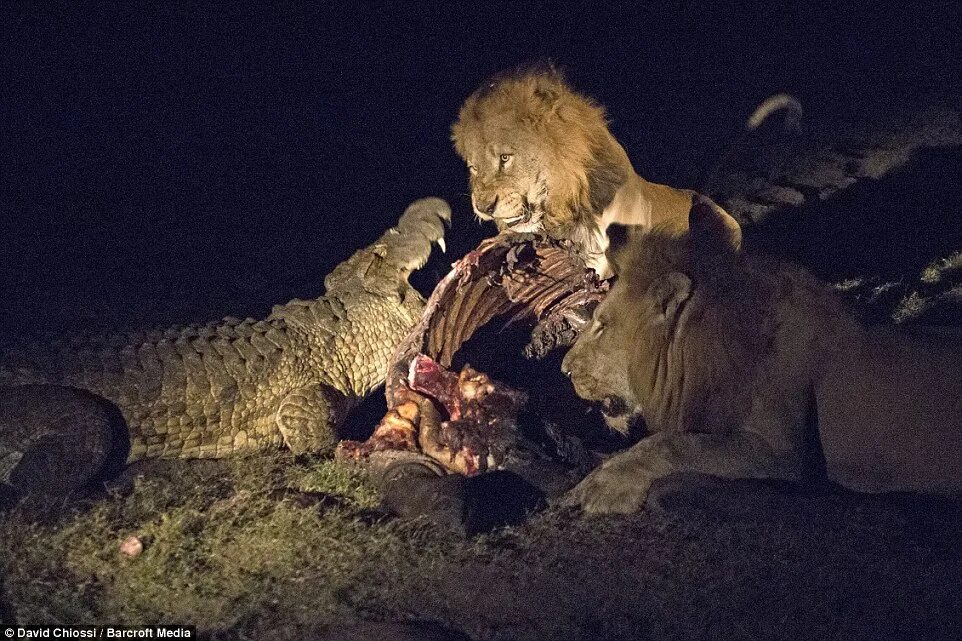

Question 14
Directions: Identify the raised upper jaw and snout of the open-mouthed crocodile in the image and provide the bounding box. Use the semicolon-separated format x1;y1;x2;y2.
324;198;451;292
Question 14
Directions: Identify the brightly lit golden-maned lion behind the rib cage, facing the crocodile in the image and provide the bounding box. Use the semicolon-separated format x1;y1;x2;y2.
451;68;772;277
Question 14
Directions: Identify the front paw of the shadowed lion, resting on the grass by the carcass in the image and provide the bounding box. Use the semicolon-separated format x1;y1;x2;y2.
560;461;651;514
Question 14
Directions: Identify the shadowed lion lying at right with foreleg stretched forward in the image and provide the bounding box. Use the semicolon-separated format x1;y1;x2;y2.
562;198;962;513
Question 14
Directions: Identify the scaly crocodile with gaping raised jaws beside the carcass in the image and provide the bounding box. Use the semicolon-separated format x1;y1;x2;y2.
0;198;451;498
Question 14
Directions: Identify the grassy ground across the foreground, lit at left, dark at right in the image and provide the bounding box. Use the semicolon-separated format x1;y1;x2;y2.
0;454;962;639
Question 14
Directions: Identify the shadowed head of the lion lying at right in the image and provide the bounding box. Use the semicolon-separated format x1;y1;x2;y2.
562;199;763;430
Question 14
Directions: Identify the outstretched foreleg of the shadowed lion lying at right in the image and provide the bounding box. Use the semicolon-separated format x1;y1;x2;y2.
562;431;801;514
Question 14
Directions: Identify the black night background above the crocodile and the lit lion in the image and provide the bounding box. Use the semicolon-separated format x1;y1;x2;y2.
0;2;962;332
